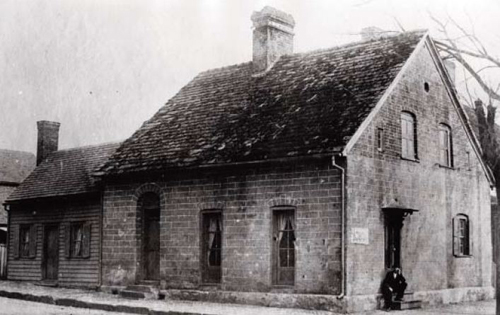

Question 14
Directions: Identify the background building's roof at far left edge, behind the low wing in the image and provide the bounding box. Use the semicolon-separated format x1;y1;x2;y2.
0;149;36;183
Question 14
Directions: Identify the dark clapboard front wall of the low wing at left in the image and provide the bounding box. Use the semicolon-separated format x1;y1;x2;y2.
8;197;101;286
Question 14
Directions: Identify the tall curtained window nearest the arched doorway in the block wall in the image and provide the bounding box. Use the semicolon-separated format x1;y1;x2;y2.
201;211;222;283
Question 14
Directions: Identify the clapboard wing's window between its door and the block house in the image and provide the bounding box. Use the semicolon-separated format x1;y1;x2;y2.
66;222;91;258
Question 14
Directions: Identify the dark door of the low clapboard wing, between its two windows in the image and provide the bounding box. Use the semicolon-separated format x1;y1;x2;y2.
43;225;59;280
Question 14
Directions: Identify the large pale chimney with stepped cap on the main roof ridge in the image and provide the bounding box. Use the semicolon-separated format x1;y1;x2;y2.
252;6;295;72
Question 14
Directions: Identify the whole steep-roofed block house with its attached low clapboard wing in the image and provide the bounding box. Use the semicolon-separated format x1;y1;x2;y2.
7;7;492;312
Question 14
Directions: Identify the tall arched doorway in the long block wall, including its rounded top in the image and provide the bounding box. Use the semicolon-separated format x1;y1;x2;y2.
140;193;160;280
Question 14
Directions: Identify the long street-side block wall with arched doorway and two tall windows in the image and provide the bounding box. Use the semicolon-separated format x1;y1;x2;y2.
103;159;341;294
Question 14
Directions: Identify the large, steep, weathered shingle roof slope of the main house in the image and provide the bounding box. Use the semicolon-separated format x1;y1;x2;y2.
100;31;424;175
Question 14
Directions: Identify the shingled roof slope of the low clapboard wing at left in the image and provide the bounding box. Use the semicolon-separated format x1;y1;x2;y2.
7;143;119;202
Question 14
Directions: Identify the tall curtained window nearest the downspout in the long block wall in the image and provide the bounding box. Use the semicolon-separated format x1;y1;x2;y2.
273;208;295;285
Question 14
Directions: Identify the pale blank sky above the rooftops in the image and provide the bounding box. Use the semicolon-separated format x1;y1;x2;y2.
0;0;500;152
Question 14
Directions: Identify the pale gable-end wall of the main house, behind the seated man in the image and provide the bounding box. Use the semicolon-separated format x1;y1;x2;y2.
347;42;492;295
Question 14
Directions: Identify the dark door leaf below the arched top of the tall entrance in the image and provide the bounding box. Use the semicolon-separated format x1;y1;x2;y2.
143;207;160;280
